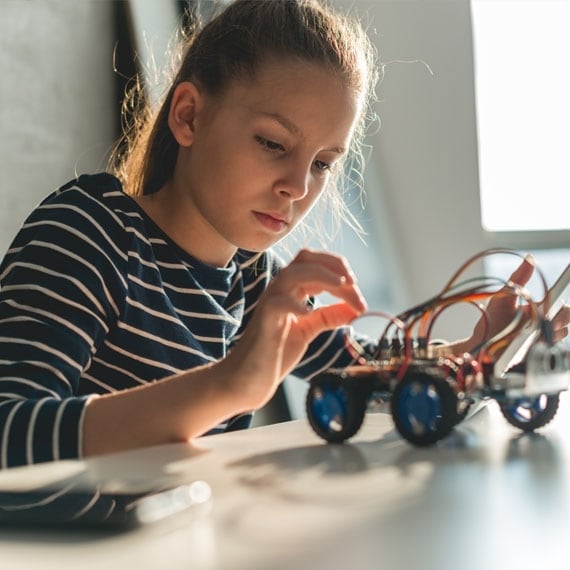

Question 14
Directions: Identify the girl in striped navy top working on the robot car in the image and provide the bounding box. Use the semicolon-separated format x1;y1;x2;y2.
0;0;560;467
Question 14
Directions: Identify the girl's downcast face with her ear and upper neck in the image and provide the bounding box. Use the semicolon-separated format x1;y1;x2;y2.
165;61;361;266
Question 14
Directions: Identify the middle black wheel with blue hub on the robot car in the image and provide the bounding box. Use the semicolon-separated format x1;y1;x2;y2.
391;372;458;447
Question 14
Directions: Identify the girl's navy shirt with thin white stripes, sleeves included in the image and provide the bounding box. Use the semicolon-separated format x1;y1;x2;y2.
0;174;360;467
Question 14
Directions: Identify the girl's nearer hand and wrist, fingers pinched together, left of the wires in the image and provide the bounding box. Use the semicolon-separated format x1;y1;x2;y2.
221;249;366;411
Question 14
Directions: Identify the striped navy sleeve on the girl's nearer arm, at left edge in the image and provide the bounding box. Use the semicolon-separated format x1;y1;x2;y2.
0;178;127;467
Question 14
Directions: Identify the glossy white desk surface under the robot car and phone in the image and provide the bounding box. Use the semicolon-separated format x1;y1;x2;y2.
0;394;570;570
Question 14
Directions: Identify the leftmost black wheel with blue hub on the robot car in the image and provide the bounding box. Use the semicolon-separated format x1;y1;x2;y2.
305;374;368;443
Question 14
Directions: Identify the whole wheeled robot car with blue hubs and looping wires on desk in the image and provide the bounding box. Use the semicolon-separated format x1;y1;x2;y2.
306;249;570;446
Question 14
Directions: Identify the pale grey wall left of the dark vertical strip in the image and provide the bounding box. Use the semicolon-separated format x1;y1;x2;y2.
0;0;115;255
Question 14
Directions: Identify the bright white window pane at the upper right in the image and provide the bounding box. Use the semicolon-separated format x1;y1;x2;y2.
472;0;570;232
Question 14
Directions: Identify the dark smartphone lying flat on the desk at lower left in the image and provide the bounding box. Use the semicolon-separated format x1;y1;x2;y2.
0;461;211;530
